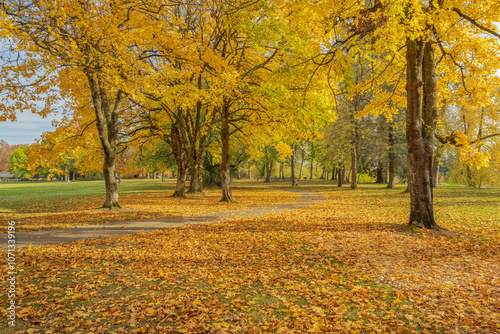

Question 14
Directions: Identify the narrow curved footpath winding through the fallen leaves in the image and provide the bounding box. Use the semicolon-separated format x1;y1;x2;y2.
3;189;324;248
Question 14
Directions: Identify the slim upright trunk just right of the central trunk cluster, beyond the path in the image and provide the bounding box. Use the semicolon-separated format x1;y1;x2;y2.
220;102;234;202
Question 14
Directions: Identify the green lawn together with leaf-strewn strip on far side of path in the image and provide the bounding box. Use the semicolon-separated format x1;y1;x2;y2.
0;180;300;233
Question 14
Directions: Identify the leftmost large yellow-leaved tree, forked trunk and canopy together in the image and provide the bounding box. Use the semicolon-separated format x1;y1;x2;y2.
1;1;154;208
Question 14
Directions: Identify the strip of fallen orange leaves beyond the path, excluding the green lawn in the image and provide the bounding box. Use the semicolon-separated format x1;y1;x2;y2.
0;188;300;233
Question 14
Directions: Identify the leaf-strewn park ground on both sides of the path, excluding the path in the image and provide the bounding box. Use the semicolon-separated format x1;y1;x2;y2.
0;181;500;333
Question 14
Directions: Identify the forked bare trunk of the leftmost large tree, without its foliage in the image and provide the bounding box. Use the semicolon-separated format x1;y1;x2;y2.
84;69;124;209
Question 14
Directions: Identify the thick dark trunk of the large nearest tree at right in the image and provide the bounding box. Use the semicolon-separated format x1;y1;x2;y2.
406;39;439;229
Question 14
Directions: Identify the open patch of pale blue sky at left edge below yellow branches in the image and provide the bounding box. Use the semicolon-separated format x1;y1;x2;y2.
0;112;58;145
